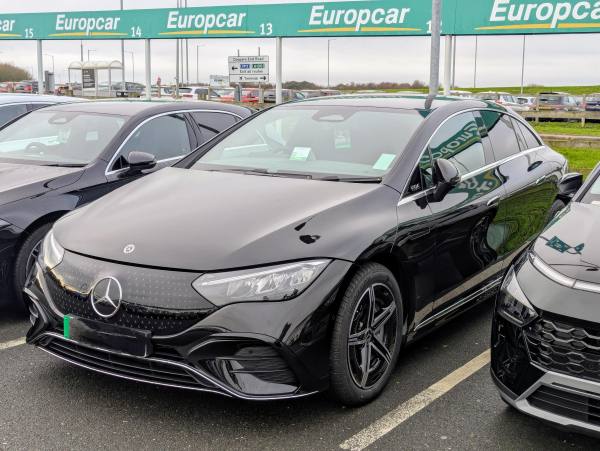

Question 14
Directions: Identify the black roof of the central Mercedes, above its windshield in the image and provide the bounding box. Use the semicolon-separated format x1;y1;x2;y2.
281;94;506;112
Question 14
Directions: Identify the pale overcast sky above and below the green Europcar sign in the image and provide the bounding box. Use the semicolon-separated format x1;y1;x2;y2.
0;0;600;88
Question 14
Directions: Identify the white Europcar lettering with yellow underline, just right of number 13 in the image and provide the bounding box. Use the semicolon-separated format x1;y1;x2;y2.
298;2;421;33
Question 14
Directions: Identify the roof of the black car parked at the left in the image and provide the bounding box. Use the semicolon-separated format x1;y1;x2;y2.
33;99;250;116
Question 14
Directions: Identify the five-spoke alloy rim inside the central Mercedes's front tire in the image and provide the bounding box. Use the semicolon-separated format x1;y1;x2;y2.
348;283;398;390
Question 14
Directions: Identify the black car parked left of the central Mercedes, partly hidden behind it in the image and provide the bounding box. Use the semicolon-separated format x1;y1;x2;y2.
0;100;252;304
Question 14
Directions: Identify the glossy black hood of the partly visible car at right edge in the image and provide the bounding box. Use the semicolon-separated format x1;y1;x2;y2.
534;202;600;283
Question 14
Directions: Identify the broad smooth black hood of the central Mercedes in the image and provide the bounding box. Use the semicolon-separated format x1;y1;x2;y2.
55;168;399;271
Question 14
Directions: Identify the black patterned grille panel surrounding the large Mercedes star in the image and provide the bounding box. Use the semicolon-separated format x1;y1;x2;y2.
44;252;216;335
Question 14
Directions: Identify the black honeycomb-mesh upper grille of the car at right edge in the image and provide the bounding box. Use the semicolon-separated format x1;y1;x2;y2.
525;318;600;381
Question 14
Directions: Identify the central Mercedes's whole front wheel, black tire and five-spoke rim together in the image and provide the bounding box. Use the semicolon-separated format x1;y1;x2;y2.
329;263;403;406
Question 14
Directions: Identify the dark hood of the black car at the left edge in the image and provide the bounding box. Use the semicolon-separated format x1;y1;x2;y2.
0;163;83;205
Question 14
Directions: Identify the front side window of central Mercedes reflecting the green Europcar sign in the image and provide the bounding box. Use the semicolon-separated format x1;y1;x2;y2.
430;113;485;174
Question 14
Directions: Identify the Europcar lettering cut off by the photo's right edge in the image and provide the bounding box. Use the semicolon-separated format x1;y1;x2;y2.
476;0;600;30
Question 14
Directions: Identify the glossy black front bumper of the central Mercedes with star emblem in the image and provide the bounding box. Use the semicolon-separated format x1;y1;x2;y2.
24;261;352;400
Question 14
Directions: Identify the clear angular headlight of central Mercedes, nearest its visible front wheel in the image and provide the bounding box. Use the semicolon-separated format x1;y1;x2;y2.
192;259;331;305
